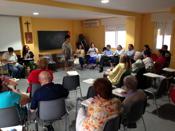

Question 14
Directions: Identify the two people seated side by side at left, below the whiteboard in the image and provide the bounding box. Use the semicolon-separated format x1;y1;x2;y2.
1;45;34;78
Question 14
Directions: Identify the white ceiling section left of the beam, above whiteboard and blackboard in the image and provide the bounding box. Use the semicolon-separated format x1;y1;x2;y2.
0;0;121;20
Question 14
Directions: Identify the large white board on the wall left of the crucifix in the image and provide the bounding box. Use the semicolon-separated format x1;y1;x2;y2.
0;16;22;51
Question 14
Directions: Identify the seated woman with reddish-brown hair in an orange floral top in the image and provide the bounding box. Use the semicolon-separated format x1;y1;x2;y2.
76;78;121;131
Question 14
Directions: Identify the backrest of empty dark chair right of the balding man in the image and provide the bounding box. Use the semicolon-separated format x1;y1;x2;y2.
63;75;80;91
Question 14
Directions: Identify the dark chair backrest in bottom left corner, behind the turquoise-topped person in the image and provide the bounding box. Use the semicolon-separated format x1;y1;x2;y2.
0;107;21;128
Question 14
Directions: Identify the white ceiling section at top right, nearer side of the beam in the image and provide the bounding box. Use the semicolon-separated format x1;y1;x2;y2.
54;0;175;13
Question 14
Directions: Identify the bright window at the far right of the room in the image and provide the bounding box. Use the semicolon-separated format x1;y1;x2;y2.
156;28;171;50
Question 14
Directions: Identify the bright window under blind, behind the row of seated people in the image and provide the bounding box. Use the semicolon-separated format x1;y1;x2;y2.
105;30;126;48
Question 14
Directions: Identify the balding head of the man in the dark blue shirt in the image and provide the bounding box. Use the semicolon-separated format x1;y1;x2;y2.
39;71;52;86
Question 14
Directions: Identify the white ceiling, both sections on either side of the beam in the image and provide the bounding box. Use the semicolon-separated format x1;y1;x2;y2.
0;0;175;20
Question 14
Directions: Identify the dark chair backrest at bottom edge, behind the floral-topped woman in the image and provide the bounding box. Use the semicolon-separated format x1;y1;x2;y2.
103;116;121;131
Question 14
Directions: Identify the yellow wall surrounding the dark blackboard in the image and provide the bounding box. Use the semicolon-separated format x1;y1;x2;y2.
21;17;82;60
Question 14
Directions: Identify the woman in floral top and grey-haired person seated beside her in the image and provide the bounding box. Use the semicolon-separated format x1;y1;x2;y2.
76;75;146;131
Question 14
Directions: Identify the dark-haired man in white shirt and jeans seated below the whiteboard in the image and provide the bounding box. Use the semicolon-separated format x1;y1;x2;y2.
2;47;24;78
